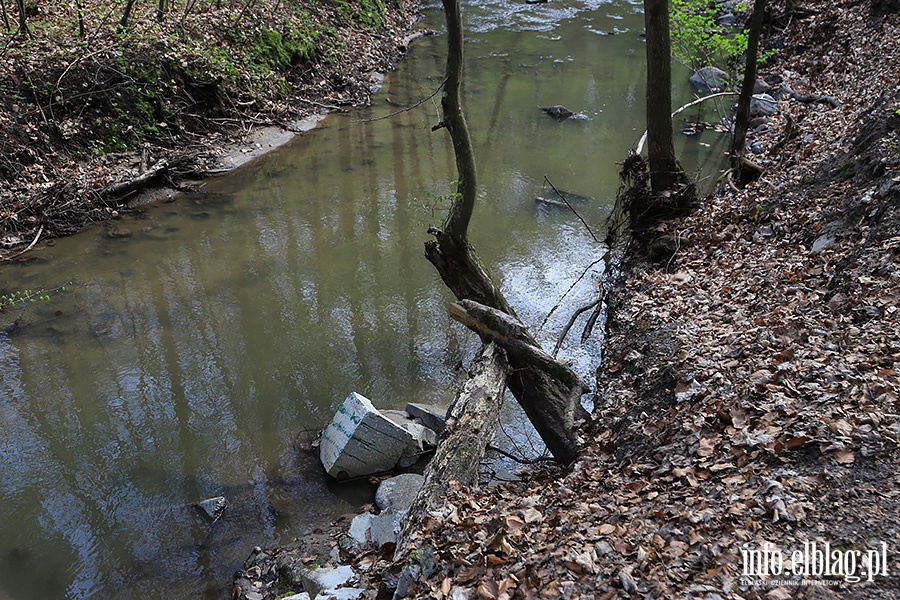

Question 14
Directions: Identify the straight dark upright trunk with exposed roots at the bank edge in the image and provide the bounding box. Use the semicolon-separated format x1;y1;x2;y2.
644;0;681;194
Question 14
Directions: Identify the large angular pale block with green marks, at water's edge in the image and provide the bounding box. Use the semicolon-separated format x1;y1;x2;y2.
319;392;413;480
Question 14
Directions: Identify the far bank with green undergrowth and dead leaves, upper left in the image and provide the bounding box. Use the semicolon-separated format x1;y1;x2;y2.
0;0;417;251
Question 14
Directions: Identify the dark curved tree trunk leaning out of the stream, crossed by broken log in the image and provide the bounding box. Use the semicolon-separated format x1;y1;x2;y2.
425;0;590;464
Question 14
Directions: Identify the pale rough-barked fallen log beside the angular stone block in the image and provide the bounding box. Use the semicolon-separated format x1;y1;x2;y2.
396;343;507;557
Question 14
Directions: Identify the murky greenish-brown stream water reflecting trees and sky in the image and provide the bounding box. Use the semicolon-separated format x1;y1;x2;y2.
0;0;718;600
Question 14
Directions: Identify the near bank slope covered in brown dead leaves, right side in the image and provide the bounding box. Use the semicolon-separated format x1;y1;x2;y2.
334;0;900;600
